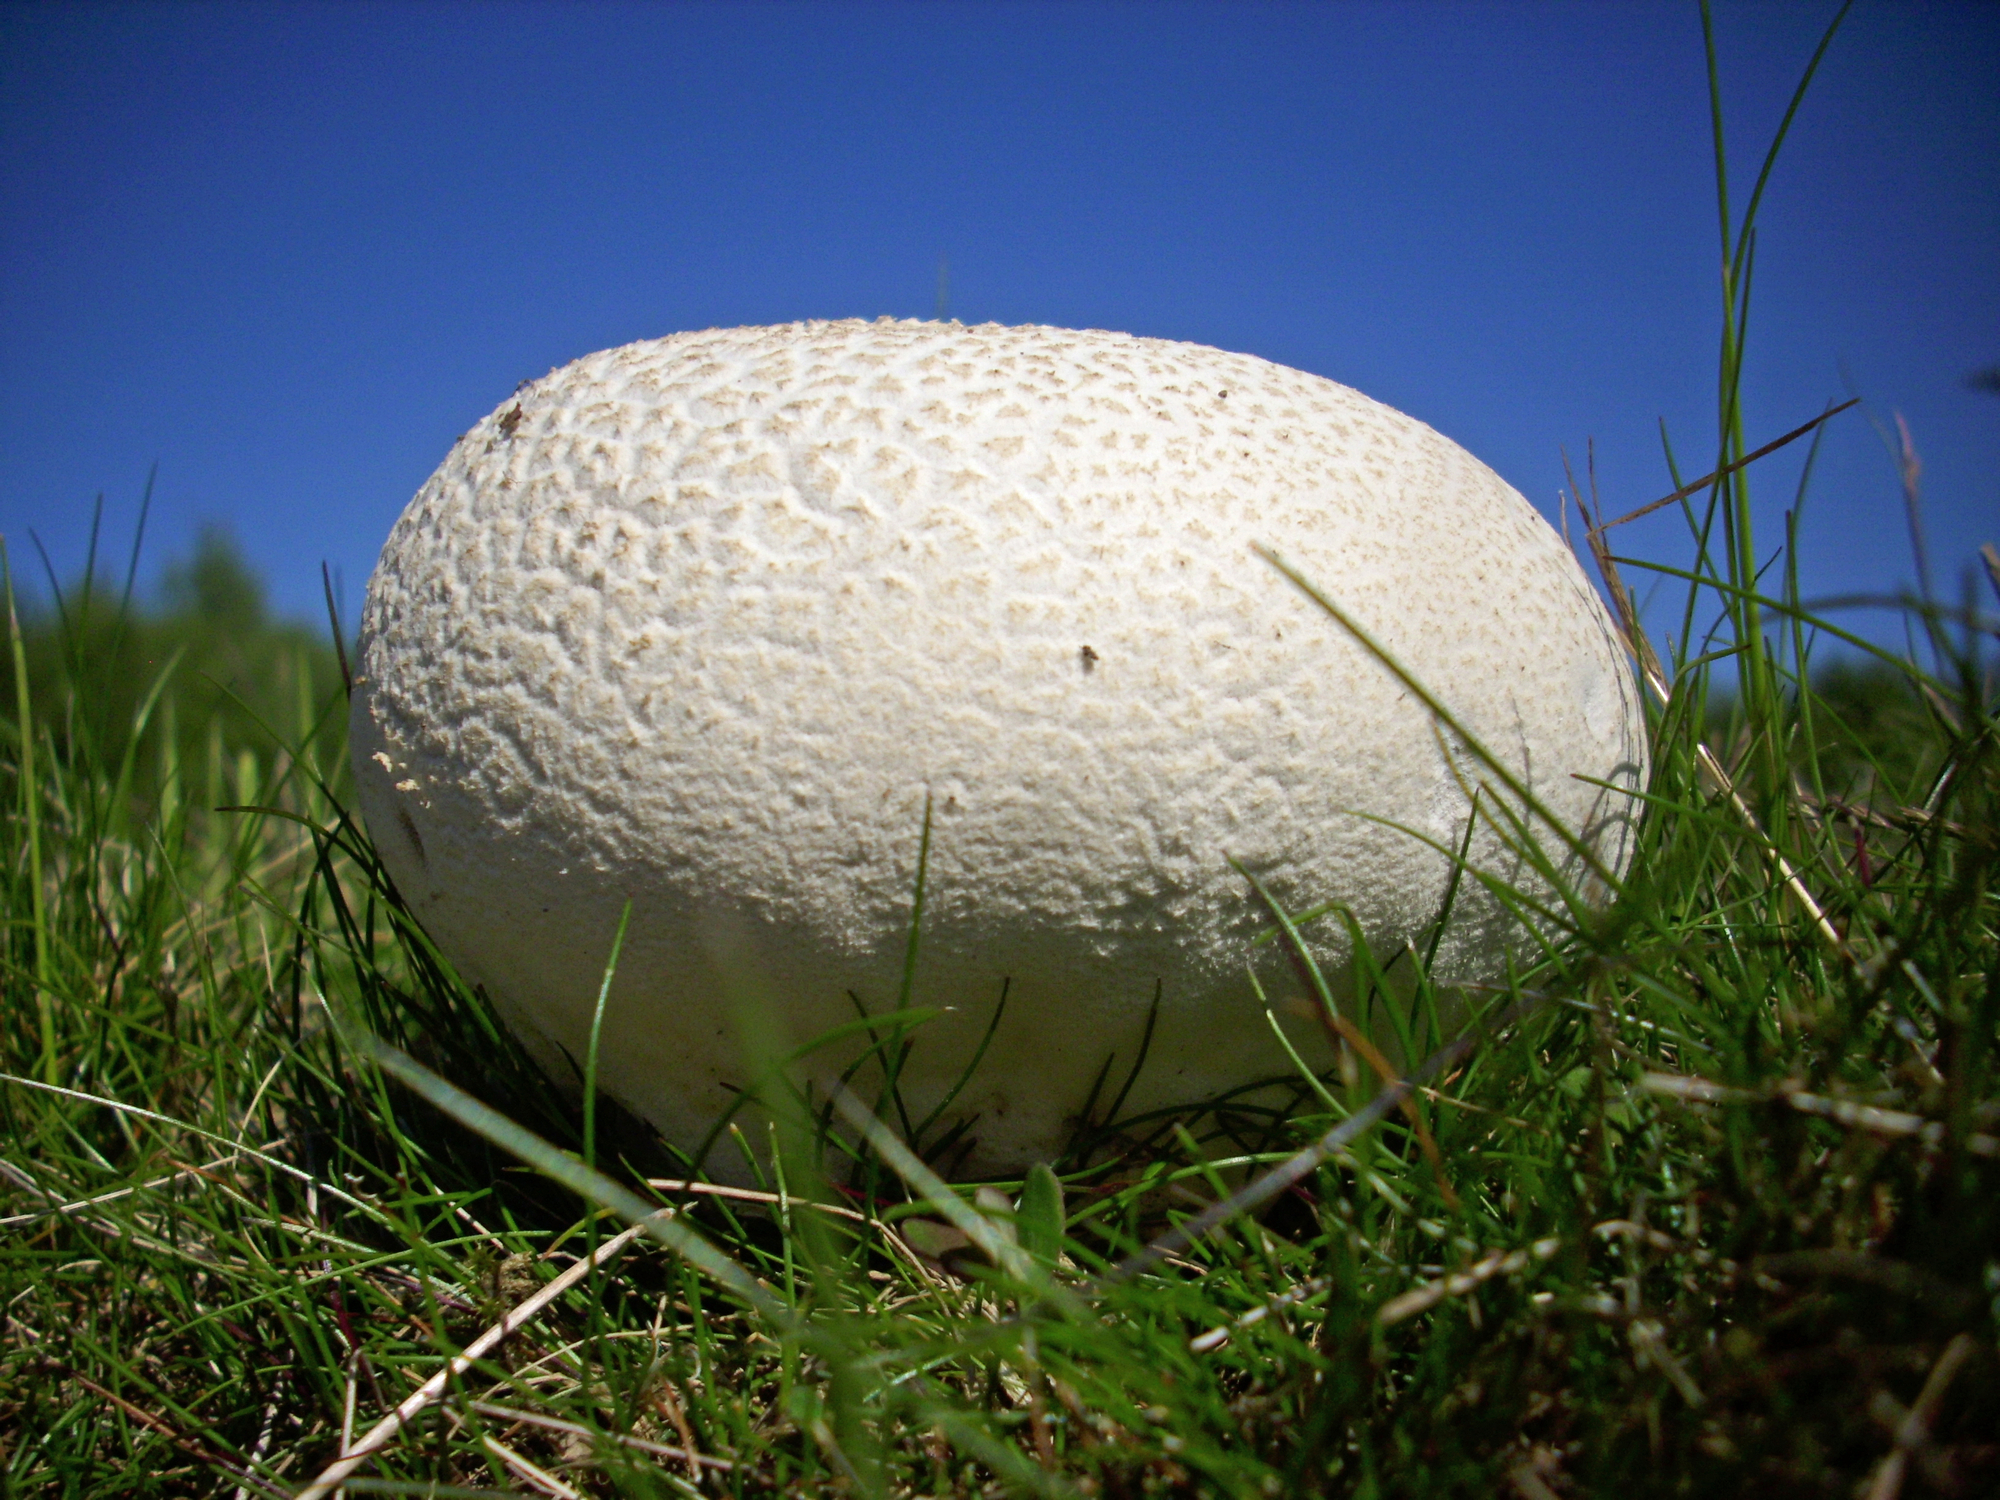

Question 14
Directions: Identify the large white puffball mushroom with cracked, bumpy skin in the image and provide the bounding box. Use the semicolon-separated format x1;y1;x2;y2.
352;318;1646;1174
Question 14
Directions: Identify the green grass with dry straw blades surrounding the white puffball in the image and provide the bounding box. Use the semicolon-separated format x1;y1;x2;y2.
0;8;2000;1500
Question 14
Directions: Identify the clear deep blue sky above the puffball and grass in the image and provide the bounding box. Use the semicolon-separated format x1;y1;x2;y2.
0;0;2000;656
